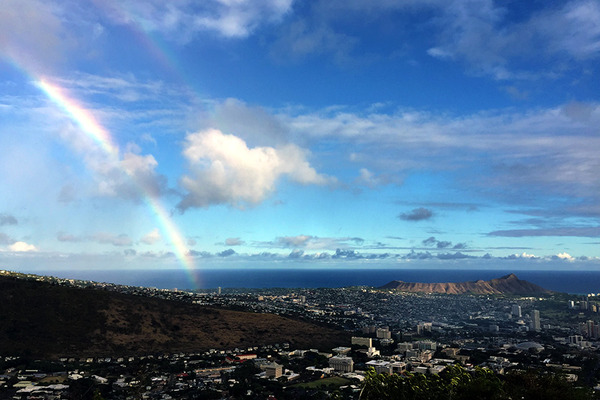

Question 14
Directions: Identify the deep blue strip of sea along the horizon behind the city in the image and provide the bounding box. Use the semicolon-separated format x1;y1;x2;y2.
23;268;600;294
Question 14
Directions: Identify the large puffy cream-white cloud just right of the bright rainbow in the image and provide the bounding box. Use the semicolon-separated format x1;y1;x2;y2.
178;129;331;212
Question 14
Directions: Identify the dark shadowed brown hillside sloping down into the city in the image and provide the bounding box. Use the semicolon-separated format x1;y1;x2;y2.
0;277;349;356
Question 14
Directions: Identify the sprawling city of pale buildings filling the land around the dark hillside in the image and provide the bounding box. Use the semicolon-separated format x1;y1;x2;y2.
0;271;600;399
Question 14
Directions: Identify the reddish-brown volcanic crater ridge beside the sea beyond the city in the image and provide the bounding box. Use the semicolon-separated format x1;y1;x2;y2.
380;274;551;294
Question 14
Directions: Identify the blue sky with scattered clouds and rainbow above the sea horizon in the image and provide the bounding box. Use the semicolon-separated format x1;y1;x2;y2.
0;0;600;276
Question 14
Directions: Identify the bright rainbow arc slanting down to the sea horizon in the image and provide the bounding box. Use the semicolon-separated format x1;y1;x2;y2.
36;79;200;288
